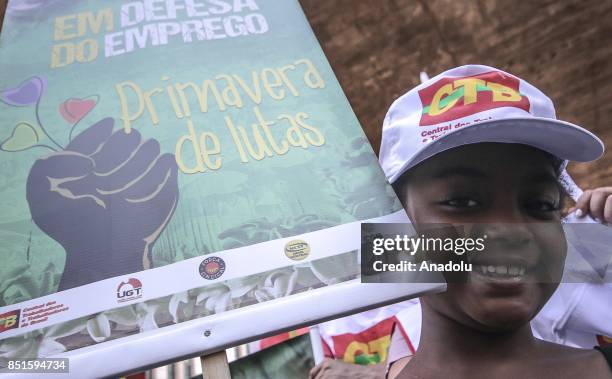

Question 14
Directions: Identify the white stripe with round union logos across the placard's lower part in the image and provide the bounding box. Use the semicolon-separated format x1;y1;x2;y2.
0;210;409;339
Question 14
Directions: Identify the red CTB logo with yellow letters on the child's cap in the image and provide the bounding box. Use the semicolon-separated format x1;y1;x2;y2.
419;71;529;126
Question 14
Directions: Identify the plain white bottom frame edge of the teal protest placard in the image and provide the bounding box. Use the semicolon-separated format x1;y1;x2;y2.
3;279;446;379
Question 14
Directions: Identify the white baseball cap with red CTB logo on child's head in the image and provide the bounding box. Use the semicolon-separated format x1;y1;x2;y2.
379;65;604;183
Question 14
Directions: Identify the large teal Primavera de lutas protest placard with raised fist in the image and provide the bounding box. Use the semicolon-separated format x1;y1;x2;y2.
0;0;441;377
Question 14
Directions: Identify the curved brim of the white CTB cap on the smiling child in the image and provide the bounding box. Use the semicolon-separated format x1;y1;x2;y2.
390;117;605;182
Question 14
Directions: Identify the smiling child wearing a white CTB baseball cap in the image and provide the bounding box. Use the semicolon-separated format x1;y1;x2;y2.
380;66;612;378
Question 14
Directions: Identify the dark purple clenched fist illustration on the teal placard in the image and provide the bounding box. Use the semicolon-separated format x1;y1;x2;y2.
27;118;179;291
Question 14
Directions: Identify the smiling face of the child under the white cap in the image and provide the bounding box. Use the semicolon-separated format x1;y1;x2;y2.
399;143;567;331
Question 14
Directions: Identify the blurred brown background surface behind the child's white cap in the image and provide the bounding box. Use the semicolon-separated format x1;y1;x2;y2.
0;0;612;187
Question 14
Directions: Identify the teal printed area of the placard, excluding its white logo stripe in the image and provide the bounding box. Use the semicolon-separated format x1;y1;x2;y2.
0;0;401;364
